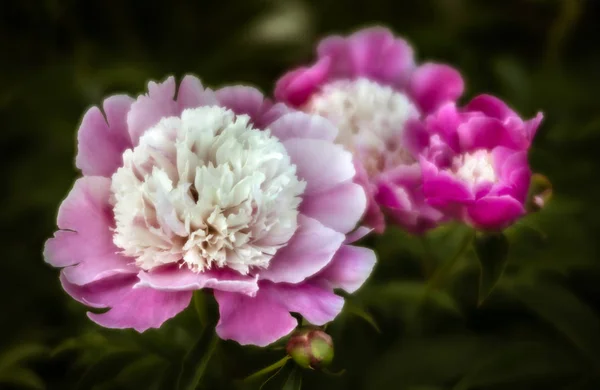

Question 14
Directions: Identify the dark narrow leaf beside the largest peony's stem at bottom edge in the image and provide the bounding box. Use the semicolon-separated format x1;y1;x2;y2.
177;327;219;390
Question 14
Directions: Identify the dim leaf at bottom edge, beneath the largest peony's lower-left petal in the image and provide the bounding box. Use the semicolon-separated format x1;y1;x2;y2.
76;350;140;390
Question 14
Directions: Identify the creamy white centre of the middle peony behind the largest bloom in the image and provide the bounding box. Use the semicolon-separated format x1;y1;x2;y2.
304;78;419;173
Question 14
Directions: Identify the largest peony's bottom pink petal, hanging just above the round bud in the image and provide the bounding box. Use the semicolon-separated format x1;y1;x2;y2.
214;289;298;347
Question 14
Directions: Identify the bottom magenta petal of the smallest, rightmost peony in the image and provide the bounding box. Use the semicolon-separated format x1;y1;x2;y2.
468;195;525;230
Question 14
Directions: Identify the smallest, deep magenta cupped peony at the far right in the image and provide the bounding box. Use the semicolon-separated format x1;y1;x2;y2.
420;95;543;230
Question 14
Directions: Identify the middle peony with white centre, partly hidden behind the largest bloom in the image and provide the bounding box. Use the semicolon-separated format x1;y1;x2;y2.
275;27;464;232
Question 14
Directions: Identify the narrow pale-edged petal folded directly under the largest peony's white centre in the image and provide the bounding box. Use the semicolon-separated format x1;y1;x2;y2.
135;265;258;295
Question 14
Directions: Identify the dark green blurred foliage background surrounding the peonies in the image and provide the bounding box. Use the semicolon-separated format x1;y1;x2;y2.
0;0;600;390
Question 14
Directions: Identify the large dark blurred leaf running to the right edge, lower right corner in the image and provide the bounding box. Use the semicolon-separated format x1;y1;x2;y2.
508;280;600;368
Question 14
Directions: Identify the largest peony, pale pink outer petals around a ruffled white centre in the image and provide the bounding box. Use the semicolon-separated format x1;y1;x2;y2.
44;76;375;346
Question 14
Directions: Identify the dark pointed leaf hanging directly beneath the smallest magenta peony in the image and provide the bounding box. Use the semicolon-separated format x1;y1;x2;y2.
475;233;509;305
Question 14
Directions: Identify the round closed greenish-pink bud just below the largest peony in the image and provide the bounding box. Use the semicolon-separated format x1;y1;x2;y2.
286;328;333;369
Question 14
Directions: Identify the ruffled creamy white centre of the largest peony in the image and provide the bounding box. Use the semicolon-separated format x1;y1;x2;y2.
112;106;306;274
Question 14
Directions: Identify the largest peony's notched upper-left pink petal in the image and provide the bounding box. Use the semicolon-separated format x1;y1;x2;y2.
75;95;133;177
